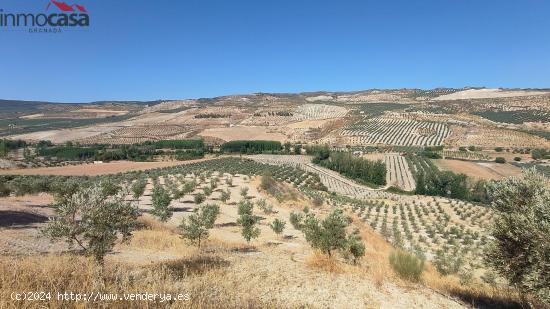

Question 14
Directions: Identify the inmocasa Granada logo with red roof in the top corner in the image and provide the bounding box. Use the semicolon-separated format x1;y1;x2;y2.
0;0;90;32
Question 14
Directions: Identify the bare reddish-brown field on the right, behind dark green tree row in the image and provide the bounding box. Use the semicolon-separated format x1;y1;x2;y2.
434;159;521;180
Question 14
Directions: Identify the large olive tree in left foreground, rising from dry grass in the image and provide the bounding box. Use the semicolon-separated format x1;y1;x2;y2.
42;183;139;264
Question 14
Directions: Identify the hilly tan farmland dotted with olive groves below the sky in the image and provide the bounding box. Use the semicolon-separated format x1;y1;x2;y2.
0;88;550;308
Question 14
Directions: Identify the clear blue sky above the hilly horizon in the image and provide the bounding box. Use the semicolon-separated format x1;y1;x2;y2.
0;0;550;102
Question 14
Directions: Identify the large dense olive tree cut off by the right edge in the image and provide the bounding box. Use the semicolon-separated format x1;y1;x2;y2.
485;169;550;302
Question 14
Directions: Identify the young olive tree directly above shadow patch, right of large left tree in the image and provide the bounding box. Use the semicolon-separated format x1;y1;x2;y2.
179;204;220;248
